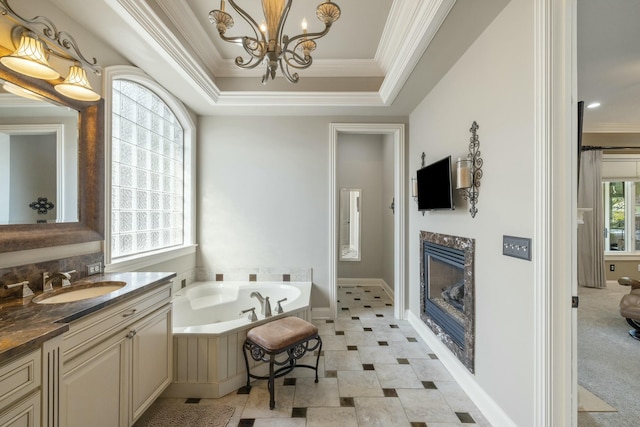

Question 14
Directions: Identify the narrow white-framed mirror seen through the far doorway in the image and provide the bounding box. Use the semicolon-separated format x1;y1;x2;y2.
338;188;362;261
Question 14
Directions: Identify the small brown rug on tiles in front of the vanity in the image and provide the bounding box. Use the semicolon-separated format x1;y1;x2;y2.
134;399;235;427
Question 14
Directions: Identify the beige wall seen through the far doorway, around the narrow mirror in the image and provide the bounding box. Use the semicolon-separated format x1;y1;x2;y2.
336;134;383;279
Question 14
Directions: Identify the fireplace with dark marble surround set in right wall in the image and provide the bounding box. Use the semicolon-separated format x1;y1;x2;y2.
420;231;475;373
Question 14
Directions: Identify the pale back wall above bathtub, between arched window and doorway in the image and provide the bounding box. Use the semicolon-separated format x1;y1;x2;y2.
197;117;404;308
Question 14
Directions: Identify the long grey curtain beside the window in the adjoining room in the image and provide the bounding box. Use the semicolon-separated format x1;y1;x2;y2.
578;150;607;288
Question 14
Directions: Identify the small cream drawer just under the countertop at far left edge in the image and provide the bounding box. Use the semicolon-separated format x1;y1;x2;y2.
0;349;42;409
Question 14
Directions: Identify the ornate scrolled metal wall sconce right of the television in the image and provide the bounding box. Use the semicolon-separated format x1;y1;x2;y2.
456;121;483;218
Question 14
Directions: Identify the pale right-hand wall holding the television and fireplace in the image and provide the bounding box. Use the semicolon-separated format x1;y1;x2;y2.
407;0;539;426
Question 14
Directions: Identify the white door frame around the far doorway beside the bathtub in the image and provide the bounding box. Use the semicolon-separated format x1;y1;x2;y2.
329;123;406;319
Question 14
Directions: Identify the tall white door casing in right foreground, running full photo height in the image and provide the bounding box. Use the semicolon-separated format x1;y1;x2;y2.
532;0;577;427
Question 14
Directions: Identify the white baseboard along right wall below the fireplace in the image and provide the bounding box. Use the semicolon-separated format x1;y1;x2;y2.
405;310;517;427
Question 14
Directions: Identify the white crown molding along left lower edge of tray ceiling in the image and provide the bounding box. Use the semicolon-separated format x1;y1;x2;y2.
114;0;220;103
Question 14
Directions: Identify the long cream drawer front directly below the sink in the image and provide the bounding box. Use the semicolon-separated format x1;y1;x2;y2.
63;282;171;363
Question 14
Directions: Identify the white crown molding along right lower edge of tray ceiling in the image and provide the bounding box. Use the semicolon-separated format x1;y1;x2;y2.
380;0;455;105
